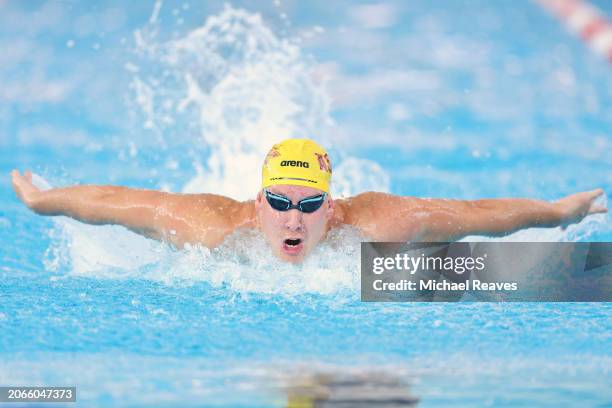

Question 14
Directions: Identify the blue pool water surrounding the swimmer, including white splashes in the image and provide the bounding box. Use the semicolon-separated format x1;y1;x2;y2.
0;1;612;407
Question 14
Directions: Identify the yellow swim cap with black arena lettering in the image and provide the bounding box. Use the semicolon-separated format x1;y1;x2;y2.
261;139;331;193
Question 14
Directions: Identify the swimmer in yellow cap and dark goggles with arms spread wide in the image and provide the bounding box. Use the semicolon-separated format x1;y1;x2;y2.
11;139;607;263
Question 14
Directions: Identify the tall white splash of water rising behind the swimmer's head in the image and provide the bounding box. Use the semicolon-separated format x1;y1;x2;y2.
130;6;389;199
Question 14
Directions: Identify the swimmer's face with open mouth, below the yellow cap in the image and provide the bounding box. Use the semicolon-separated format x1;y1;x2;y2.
255;185;334;263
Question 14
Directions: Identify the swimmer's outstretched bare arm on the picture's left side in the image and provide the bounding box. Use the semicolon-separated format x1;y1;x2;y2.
11;171;251;248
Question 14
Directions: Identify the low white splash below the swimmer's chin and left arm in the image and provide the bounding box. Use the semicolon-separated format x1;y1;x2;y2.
45;218;362;295
